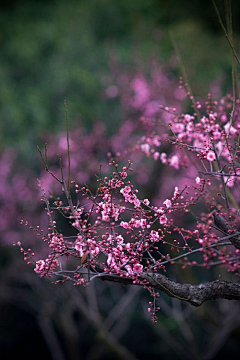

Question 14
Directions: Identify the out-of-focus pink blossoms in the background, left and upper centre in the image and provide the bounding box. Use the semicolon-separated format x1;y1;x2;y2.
0;59;180;246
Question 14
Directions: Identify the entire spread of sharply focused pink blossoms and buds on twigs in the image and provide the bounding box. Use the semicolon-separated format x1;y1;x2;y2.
16;86;240;320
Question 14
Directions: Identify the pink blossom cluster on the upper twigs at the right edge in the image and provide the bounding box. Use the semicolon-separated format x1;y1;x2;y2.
136;92;240;205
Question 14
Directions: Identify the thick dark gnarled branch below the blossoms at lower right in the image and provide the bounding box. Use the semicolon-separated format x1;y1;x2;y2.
95;265;240;306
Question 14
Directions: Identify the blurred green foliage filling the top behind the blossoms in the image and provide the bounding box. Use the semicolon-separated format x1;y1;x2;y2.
0;0;239;167
